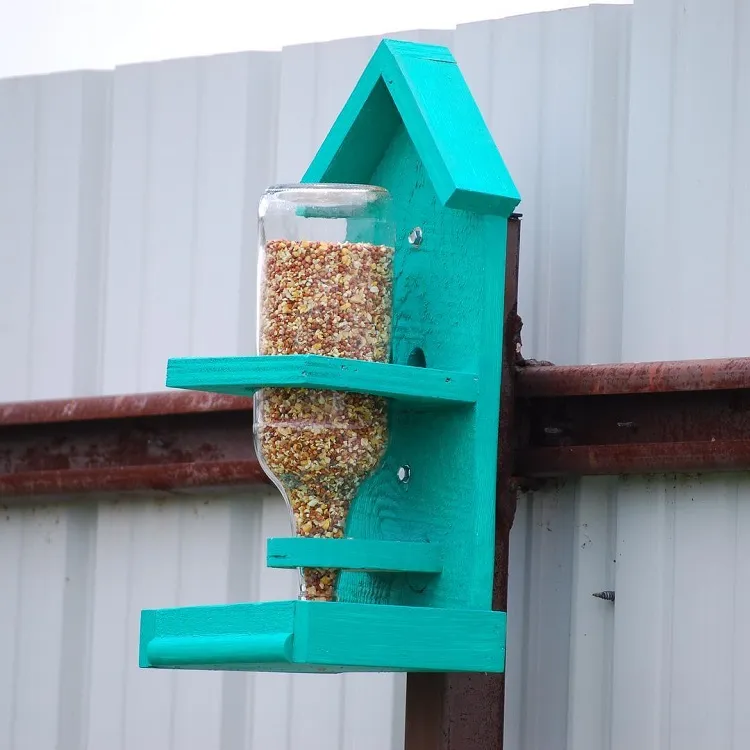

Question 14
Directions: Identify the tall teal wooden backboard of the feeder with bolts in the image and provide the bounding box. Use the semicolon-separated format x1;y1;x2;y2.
308;128;507;609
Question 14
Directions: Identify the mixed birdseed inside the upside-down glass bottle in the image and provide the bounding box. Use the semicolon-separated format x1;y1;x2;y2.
256;240;393;601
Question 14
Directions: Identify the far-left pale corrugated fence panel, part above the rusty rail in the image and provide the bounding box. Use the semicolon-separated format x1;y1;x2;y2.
0;73;111;400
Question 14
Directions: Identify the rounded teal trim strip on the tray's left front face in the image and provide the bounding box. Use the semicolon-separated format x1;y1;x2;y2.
146;633;292;667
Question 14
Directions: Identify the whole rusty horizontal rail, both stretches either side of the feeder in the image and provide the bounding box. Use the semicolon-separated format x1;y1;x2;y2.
0;358;750;496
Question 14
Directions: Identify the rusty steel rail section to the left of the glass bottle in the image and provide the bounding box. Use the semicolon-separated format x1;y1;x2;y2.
0;392;268;496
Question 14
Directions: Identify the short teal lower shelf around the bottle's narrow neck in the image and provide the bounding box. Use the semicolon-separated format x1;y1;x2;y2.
266;537;443;573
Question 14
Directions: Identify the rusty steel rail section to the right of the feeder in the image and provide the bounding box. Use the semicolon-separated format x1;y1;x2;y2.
514;358;750;477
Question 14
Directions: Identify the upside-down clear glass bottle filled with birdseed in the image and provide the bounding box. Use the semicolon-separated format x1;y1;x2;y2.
254;184;395;601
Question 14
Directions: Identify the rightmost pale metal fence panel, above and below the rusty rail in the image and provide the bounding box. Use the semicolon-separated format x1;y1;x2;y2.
612;0;750;750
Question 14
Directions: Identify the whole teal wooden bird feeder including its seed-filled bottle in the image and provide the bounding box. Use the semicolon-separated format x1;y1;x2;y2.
140;40;519;672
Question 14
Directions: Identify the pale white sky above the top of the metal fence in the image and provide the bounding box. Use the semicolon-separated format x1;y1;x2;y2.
0;0;627;78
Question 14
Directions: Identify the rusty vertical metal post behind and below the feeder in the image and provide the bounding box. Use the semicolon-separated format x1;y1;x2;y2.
406;216;521;750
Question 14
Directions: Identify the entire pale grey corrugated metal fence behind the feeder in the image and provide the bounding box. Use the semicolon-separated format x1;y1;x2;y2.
0;0;750;750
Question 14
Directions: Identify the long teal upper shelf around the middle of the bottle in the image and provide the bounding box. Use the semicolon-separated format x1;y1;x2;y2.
167;354;479;405
